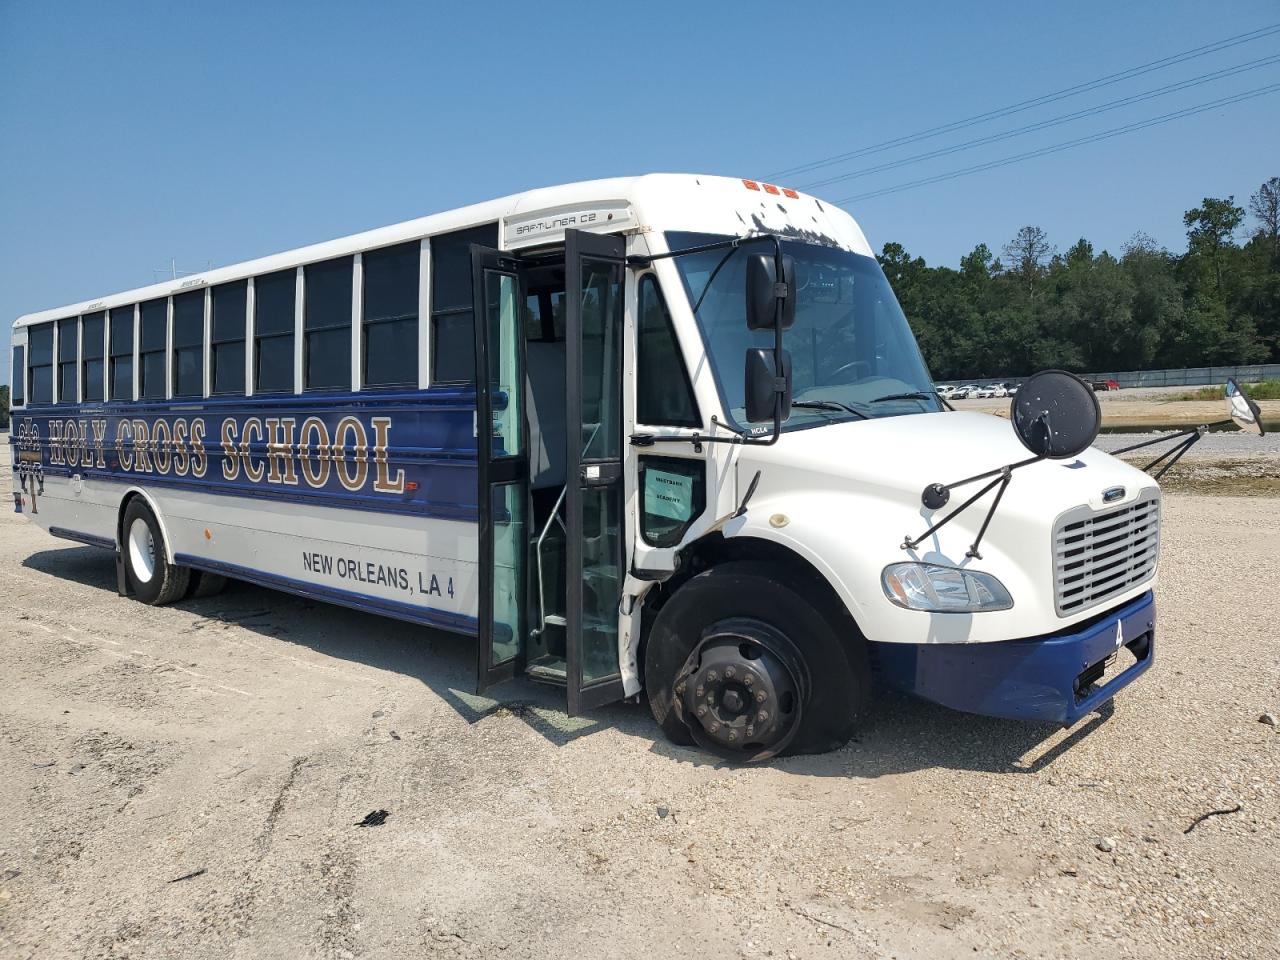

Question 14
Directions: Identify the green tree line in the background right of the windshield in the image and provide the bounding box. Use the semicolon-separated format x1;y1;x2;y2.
879;177;1280;380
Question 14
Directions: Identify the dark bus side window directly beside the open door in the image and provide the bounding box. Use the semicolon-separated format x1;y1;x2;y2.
431;224;498;384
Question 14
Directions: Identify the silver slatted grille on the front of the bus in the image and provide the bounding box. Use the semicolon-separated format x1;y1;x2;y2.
1053;490;1160;617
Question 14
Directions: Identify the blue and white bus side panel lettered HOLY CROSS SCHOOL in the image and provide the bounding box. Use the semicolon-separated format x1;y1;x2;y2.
13;389;477;634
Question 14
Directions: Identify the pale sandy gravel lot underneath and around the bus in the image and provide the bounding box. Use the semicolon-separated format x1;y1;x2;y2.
0;445;1280;960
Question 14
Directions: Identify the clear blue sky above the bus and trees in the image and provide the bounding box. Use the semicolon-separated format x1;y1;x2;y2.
0;0;1280;381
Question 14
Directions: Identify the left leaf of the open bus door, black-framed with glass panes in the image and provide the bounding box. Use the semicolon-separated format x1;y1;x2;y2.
471;247;529;692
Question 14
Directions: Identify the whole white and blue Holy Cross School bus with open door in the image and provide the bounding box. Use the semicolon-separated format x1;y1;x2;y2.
10;174;1160;760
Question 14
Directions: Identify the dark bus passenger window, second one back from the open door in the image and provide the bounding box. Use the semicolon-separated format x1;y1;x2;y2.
361;241;422;387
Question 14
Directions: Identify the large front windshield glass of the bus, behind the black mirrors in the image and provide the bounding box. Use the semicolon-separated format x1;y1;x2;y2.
667;233;942;429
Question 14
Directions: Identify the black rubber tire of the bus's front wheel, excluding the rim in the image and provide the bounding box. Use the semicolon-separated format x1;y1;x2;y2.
644;562;870;759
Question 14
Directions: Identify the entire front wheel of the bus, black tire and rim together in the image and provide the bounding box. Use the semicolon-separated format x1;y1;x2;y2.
645;562;869;762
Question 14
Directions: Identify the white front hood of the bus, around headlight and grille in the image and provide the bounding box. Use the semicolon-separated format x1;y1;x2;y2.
724;412;1160;643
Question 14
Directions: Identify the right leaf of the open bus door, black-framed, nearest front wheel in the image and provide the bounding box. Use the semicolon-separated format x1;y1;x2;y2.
566;230;626;714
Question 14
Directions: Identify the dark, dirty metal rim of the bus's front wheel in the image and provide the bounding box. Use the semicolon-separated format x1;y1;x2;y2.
675;618;808;760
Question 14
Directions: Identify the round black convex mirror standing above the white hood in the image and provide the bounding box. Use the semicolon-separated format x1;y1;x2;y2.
1009;370;1102;460
